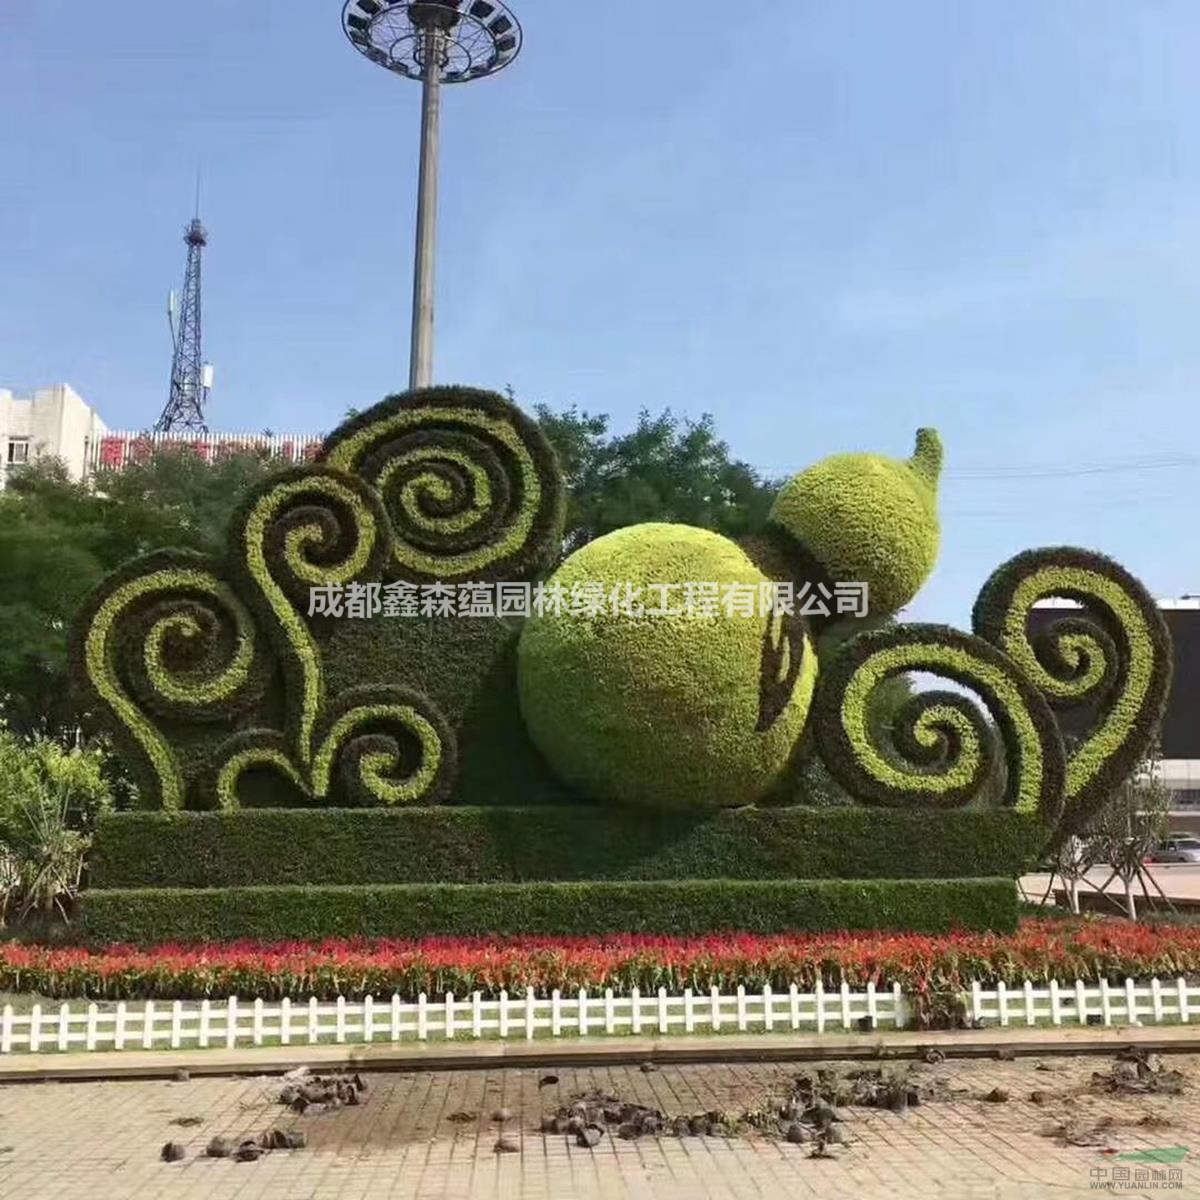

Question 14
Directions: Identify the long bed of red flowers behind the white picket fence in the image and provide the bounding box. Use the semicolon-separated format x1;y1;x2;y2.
0;919;1200;1000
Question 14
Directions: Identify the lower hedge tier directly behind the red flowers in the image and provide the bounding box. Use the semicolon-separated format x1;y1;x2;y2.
80;878;1018;946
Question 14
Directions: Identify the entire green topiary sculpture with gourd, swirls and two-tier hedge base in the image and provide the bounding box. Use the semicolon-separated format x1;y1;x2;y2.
72;388;1170;940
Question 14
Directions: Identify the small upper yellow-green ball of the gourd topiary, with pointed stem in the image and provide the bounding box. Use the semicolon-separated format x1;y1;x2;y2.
770;430;942;616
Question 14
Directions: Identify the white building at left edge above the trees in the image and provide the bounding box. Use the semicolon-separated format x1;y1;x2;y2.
0;383;108;487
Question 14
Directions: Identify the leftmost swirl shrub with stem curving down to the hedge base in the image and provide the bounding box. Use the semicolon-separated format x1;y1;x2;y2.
72;551;272;809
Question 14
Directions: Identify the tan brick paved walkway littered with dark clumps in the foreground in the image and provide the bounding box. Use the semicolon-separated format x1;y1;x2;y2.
0;1055;1200;1200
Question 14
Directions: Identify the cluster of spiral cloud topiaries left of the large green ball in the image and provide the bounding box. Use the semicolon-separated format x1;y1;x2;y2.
76;388;563;809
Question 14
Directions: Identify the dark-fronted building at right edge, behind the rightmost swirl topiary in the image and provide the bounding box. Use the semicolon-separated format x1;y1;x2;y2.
1032;596;1200;824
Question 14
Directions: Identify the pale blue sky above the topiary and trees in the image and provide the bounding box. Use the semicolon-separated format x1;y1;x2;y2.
0;0;1200;623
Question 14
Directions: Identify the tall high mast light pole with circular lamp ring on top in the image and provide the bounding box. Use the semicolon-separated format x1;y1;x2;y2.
342;0;521;389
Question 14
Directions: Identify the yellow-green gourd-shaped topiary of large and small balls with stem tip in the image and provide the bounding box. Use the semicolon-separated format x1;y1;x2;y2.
518;430;942;808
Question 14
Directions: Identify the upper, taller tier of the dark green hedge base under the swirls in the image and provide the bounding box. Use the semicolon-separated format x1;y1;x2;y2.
89;805;1045;892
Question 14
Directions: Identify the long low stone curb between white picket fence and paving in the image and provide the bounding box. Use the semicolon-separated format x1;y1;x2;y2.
0;1025;1200;1086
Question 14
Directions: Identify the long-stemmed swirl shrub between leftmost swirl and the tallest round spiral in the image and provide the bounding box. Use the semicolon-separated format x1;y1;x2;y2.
230;467;391;766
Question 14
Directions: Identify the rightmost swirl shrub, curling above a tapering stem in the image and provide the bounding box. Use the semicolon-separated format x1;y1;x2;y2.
973;547;1171;835
